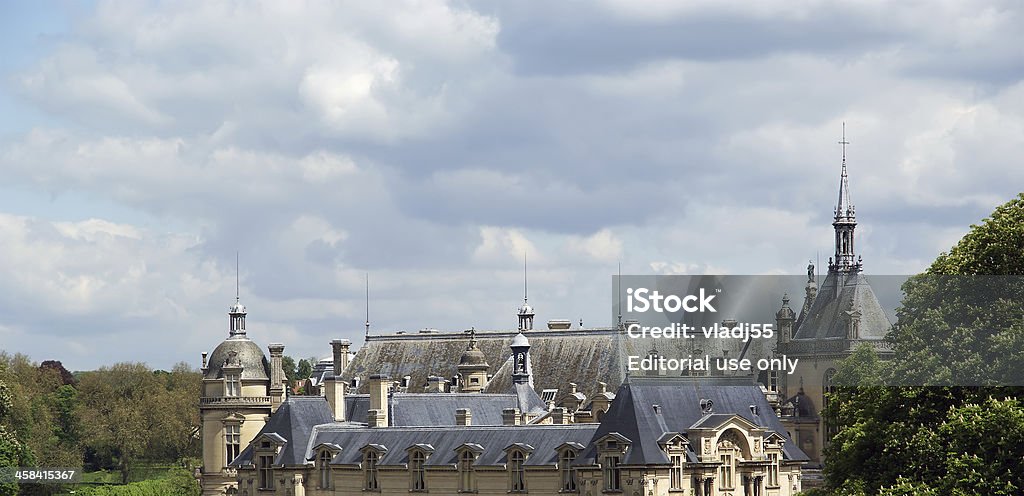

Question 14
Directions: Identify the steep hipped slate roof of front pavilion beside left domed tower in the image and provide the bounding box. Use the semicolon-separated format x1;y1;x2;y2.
230;397;334;466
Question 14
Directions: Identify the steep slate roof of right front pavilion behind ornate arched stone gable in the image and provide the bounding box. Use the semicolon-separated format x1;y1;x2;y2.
575;376;808;464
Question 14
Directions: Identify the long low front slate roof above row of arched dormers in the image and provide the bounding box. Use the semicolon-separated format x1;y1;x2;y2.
306;424;597;466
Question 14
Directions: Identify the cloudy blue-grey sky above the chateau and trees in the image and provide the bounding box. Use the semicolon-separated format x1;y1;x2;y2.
0;0;1024;369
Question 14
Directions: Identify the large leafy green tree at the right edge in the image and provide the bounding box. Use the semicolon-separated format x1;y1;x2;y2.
825;194;1024;495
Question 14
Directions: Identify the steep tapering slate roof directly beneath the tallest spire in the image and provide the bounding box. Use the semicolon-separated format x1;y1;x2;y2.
793;272;892;339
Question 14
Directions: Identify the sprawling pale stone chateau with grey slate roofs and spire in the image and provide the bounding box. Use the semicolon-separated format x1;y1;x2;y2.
200;143;890;496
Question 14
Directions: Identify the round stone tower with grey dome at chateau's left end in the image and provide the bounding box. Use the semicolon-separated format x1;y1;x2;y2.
199;296;285;495
